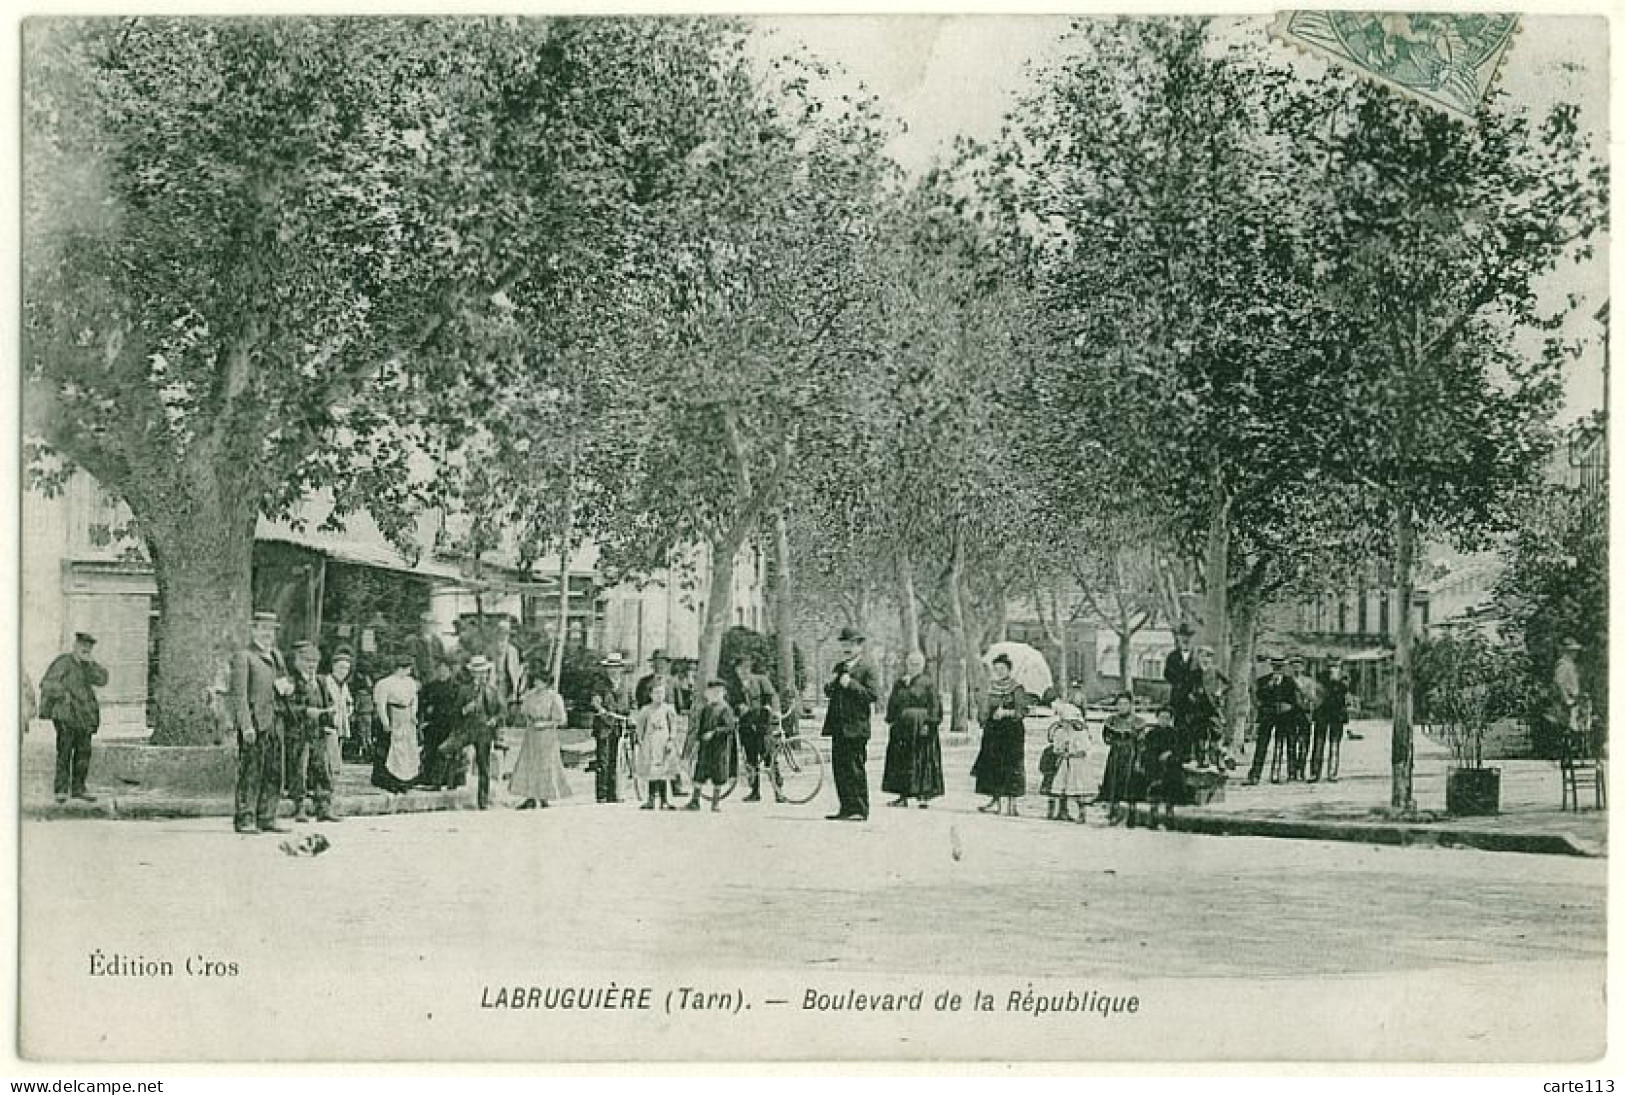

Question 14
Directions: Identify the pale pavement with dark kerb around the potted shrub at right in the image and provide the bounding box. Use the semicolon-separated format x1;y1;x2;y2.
1175;720;1609;856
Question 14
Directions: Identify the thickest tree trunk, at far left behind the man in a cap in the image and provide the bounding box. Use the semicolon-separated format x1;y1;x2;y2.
138;503;255;746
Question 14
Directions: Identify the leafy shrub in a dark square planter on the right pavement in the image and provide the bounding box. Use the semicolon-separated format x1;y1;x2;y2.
1417;634;1503;816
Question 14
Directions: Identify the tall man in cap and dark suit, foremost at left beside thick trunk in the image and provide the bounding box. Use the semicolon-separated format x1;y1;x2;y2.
228;612;294;833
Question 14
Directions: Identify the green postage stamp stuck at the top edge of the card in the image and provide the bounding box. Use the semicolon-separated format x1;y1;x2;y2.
1272;11;1518;120
